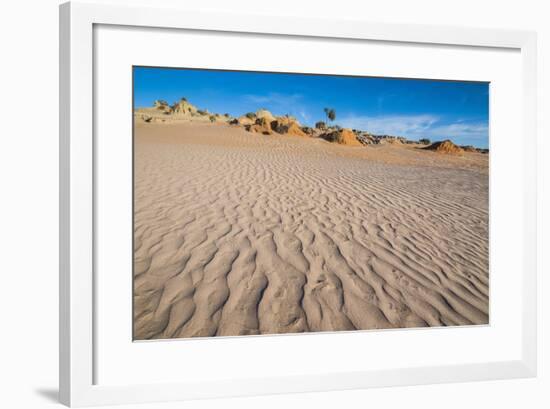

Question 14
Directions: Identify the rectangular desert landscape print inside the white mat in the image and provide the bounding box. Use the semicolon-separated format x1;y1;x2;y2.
132;66;490;340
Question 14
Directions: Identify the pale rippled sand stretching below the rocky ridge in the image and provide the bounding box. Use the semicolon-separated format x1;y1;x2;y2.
134;122;489;339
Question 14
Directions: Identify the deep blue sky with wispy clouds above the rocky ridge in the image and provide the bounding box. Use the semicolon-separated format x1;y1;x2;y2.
134;67;489;148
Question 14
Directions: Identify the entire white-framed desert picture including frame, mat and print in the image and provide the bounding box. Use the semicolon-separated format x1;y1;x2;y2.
60;2;536;406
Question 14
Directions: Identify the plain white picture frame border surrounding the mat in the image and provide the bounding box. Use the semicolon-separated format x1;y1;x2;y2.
60;2;537;406
